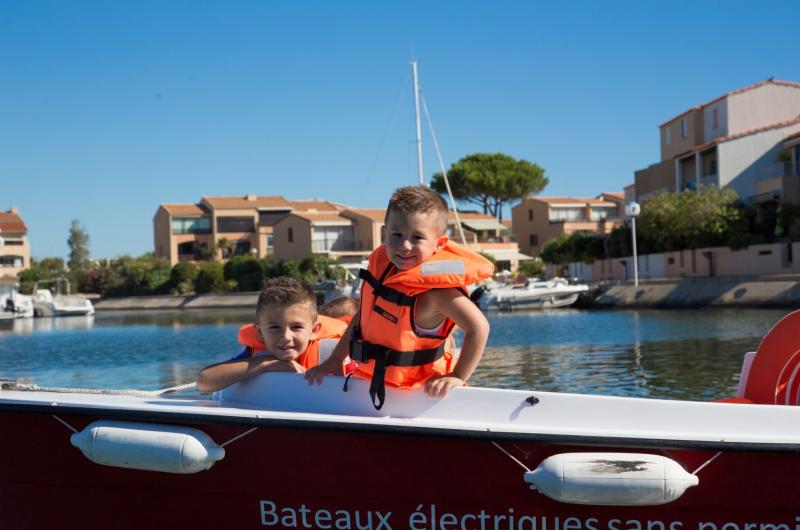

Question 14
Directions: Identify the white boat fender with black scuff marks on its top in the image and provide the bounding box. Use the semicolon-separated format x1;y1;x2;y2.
525;453;699;506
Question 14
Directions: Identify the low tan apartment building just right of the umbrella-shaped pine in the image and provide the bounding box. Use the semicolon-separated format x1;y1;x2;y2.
511;192;625;255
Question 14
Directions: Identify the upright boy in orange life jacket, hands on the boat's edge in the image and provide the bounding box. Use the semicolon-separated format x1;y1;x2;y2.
305;186;494;409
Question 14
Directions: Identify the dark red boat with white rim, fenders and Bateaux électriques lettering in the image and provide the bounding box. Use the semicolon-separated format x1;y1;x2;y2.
0;312;800;530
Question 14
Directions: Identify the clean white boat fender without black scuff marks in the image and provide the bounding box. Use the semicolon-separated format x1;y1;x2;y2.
70;420;225;474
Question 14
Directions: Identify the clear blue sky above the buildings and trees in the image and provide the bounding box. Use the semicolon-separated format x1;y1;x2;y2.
0;0;800;257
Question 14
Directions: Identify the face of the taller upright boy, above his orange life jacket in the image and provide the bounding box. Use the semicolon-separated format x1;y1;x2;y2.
384;210;447;270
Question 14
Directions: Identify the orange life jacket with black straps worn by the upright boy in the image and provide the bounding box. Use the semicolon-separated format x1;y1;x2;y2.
350;242;494;409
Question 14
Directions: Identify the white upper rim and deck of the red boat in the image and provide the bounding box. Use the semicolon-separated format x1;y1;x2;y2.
0;373;800;450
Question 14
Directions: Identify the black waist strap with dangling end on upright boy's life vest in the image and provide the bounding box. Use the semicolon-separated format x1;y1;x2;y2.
350;326;445;410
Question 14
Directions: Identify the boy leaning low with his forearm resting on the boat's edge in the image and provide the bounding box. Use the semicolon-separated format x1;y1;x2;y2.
197;276;347;392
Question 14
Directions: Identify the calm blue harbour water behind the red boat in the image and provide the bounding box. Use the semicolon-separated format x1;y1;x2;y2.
0;309;787;400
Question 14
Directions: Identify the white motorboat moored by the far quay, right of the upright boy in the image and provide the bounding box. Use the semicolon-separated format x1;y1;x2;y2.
473;278;589;311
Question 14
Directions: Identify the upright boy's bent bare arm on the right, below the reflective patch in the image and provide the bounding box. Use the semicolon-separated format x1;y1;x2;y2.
425;289;489;397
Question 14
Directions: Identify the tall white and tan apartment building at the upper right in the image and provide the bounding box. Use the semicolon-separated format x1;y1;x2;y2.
626;79;800;204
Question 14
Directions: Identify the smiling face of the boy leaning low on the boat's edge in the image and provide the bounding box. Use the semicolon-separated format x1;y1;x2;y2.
256;303;322;361
